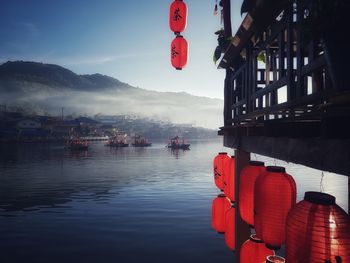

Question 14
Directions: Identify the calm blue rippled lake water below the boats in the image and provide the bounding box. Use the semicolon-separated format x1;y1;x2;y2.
0;139;348;263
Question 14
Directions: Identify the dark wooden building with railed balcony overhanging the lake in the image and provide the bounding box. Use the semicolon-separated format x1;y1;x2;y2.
219;0;350;260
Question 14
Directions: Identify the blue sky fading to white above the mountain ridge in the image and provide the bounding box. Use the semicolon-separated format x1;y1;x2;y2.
0;0;242;98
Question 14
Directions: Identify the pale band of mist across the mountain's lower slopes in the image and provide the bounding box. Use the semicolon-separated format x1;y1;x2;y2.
0;83;223;129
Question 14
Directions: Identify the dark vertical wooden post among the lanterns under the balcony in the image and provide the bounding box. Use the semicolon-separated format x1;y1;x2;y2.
235;149;250;263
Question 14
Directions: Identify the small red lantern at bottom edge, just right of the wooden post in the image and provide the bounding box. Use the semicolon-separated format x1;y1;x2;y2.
239;234;275;263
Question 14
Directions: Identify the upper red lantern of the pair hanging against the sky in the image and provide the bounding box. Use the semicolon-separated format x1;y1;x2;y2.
169;0;187;34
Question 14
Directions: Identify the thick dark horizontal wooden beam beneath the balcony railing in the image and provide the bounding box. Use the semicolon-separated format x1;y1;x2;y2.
224;132;350;176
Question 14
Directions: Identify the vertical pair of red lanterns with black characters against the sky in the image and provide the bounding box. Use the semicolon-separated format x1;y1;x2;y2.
169;0;188;70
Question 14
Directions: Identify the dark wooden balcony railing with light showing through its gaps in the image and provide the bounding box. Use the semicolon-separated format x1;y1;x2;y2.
220;0;350;126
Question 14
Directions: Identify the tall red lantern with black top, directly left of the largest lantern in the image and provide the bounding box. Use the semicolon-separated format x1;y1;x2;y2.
254;166;296;250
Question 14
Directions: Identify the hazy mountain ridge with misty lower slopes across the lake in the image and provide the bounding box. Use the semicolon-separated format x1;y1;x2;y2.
0;61;223;129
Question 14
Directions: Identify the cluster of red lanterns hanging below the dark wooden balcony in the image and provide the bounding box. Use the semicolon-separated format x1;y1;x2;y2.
213;153;350;263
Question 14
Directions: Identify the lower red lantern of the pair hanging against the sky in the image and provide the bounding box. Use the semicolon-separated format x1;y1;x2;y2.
170;36;188;70
